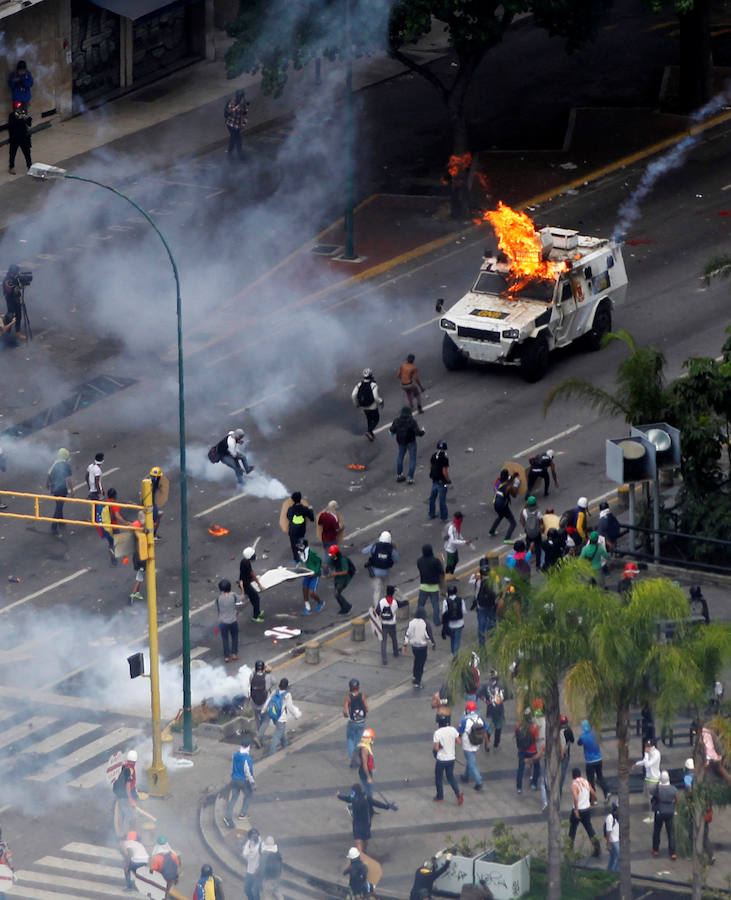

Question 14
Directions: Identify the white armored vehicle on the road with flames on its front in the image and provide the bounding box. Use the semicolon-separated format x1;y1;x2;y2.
437;203;627;382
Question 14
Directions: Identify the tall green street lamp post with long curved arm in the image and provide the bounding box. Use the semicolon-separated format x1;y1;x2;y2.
28;163;195;753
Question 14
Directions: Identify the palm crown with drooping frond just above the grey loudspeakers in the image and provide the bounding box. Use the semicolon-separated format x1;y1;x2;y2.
543;331;667;424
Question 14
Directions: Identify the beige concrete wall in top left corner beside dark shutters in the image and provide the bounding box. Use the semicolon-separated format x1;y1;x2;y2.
0;0;71;124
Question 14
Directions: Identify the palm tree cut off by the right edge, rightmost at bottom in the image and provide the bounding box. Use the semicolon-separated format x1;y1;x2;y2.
657;625;731;900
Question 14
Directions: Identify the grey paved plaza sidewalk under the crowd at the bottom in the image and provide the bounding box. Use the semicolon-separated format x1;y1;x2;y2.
133;567;731;898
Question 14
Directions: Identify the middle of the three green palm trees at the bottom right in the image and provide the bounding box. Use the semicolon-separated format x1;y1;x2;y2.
564;578;688;900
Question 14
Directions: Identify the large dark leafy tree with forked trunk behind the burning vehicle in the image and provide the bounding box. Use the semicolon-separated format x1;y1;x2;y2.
226;0;609;218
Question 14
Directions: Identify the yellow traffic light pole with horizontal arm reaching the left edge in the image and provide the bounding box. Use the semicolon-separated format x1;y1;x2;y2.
0;477;168;796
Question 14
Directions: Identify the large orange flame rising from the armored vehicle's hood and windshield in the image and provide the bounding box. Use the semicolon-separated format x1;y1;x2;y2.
477;203;568;294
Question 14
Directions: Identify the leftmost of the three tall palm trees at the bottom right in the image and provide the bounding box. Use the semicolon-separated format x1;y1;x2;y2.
493;559;603;900
